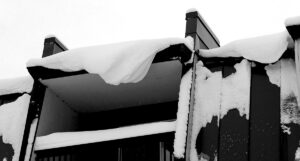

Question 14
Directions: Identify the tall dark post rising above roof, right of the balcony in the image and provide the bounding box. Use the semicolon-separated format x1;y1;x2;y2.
184;11;219;161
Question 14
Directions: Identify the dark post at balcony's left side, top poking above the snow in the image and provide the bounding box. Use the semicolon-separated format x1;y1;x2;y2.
19;37;67;161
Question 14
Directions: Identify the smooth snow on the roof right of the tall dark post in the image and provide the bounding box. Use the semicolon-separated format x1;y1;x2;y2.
199;31;290;64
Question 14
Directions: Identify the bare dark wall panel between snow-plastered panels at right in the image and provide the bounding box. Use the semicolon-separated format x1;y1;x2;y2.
249;63;281;161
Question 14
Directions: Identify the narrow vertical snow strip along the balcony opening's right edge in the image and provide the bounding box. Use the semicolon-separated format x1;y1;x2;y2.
174;69;192;158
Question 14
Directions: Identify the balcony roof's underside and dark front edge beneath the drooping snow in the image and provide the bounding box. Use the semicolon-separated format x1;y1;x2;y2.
27;38;192;112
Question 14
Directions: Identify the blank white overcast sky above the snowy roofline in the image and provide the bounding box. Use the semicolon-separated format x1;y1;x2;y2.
0;0;300;78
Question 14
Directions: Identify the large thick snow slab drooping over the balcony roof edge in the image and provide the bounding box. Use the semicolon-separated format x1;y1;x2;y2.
27;38;193;85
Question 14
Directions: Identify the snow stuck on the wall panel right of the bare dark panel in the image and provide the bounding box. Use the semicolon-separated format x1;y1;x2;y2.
280;59;300;125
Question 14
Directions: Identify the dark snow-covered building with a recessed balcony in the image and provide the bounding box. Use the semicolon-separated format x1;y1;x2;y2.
0;11;300;161
